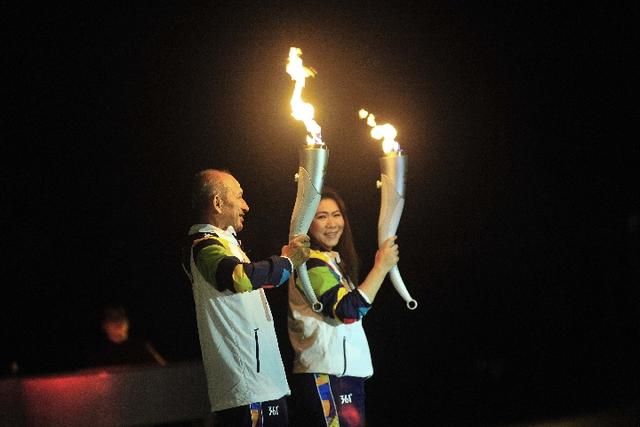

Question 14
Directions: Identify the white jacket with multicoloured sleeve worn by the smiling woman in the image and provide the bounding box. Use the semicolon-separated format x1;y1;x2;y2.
288;250;373;378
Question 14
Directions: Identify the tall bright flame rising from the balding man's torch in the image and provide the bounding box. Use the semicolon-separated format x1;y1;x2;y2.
287;47;324;145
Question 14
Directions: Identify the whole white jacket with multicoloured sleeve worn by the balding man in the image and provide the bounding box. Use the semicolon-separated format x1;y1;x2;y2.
185;224;292;411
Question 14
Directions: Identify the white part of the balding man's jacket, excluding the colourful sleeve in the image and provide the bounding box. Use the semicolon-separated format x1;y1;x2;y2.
190;225;291;411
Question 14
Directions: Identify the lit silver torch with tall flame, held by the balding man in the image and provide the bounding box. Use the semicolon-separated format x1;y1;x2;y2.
287;47;329;312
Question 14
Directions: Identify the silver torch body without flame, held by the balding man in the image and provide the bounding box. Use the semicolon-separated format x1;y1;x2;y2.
289;145;329;312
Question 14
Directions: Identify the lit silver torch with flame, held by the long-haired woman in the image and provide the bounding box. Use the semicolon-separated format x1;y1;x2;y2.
358;110;418;310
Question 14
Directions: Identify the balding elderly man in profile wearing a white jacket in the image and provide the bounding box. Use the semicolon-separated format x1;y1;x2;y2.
185;169;309;426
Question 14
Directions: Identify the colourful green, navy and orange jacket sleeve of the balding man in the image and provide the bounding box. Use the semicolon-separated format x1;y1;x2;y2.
193;237;291;292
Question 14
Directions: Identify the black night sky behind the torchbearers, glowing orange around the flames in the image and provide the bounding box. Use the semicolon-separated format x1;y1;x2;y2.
0;1;640;421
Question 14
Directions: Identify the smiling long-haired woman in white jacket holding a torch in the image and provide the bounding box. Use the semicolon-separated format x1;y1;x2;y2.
288;186;398;426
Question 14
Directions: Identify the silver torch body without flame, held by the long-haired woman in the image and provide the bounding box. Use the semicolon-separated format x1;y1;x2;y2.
377;152;418;310
